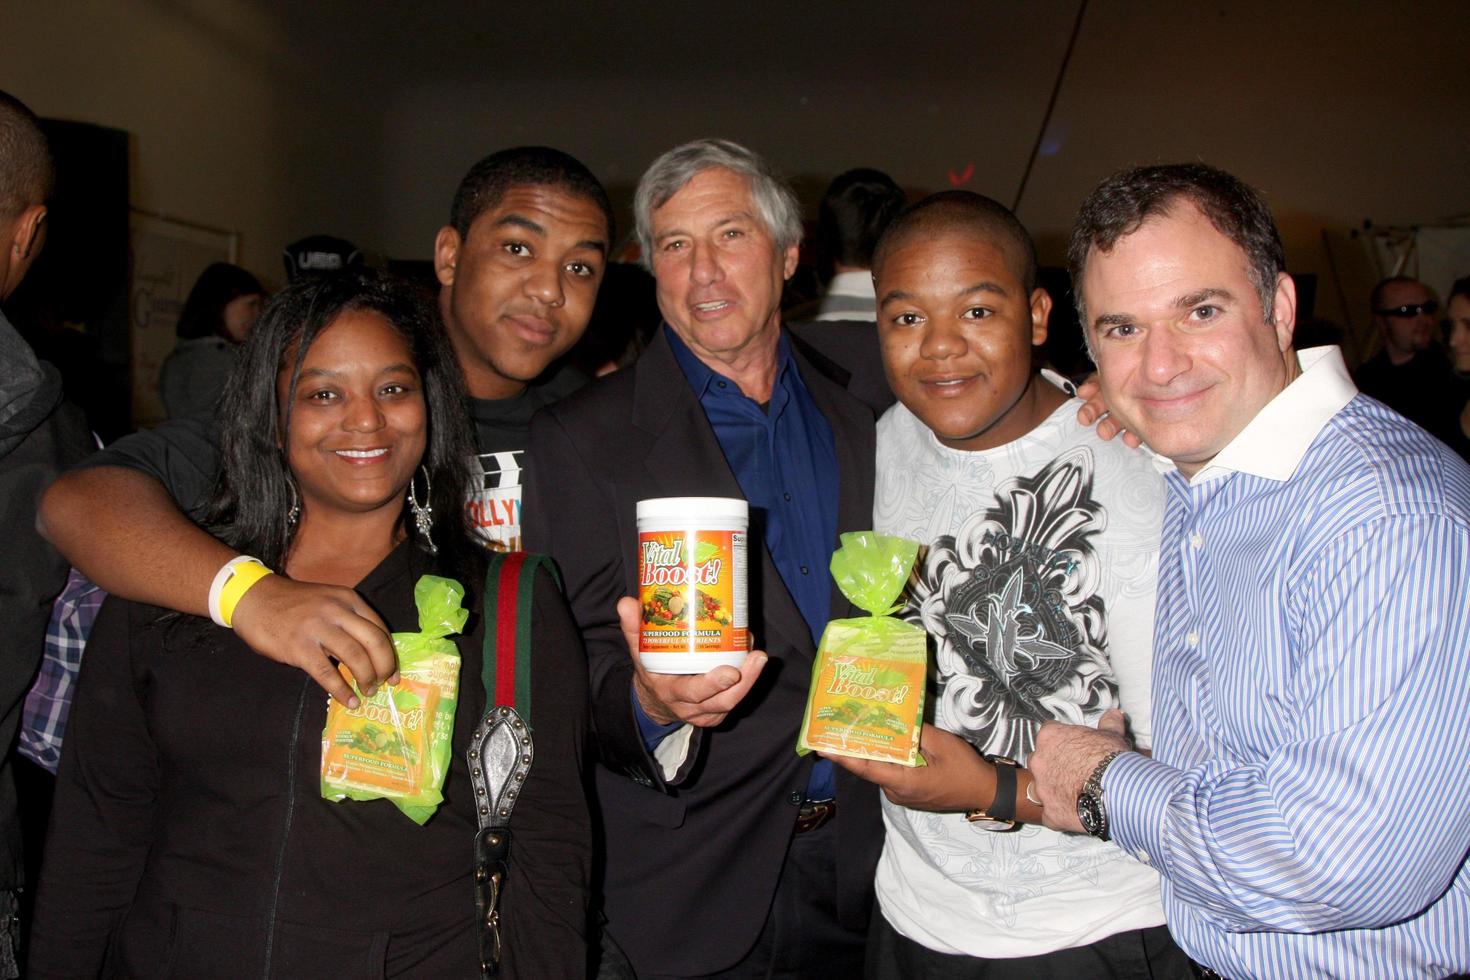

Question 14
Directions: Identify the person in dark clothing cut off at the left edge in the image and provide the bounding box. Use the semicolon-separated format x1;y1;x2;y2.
0;91;93;980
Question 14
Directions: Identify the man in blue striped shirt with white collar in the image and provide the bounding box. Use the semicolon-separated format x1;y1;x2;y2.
1029;165;1470;979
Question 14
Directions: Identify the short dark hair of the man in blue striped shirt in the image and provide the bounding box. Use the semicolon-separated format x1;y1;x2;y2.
1067;163;1286;323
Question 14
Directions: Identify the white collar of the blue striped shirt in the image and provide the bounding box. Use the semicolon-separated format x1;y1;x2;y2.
1155;347;1358;485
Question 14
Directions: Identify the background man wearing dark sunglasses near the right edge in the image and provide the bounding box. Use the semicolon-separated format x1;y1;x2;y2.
1354;276;1458;439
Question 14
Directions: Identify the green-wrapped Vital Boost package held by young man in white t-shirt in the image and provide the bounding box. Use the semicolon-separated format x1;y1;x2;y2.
797;530;929;765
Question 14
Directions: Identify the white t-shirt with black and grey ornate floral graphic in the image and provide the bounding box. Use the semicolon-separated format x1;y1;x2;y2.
873;382;1164;958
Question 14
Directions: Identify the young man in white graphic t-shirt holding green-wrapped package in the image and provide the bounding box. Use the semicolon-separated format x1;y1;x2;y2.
836;191;1189;979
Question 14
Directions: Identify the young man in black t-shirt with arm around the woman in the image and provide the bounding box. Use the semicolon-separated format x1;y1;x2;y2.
41;147;613;704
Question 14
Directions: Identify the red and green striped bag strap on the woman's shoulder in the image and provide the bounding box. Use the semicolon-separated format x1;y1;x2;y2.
481;551;557;724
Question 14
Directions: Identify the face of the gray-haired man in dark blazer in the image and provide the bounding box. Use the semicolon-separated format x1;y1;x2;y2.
650;167;797;364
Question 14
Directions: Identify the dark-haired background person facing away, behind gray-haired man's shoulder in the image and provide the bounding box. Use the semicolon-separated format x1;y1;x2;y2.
813;167;904;320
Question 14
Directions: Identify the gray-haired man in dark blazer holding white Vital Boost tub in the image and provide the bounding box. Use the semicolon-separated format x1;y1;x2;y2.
525;140;882;977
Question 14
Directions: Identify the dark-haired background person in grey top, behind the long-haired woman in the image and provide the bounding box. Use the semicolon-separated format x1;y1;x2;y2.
159;262;266;419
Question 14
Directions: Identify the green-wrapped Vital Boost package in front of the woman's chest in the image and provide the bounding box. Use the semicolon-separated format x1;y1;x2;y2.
322;574;469;824
